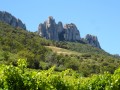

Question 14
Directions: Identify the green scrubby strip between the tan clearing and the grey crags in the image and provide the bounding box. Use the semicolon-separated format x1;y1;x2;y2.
53;41;109;55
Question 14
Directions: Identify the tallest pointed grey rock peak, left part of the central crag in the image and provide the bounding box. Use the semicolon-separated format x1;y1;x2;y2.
38;16;59;41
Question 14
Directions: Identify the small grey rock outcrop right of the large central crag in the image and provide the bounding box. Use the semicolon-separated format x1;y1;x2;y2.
84;34;101;49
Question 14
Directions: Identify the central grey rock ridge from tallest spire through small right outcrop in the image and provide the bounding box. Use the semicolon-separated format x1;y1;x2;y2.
37;16;101;49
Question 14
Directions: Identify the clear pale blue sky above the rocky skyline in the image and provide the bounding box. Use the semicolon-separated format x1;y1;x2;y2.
0;0;120;54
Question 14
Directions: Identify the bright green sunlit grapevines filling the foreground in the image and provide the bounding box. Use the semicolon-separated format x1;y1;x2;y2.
0;59;120;90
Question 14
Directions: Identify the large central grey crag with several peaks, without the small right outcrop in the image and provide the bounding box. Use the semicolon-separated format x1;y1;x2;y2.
38;16;80;41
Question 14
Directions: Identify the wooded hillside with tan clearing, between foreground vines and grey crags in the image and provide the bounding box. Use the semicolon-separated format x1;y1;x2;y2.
0;22;120;76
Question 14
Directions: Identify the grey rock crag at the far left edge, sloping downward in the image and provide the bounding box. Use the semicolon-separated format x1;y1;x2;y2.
0;11;26;30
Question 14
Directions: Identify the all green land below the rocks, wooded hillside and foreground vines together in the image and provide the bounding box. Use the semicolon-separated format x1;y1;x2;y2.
0;22;120;90
